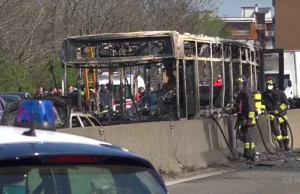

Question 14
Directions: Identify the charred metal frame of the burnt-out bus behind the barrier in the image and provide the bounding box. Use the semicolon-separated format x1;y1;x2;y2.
62;31;259;119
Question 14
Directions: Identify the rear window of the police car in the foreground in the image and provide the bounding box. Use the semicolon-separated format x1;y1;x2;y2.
0;165;166;194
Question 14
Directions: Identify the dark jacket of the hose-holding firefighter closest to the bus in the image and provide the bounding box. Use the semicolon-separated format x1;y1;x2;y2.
227;89;256;127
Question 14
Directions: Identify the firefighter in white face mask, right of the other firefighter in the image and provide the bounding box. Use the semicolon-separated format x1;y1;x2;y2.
262;77;290;151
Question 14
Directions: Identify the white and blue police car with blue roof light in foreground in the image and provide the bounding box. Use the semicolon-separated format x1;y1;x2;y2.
0;100;167;194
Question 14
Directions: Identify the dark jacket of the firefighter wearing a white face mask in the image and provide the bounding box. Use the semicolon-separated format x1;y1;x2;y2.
261;89;289;116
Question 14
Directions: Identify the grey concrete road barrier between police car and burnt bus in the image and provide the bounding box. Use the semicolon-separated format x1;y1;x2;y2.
59;113;274;172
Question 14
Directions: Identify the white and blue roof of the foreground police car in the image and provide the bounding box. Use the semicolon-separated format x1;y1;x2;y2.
0;126;154;163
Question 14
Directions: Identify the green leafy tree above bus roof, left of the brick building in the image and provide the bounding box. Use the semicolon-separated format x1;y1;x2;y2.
192;14;231;38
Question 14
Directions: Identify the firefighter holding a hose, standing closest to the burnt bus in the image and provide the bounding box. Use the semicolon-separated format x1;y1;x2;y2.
226;75;256;161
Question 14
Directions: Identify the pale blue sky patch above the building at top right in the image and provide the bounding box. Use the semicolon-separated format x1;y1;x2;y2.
219;0;274;17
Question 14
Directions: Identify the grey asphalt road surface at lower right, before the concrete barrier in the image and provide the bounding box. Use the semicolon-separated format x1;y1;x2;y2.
168;153;300;194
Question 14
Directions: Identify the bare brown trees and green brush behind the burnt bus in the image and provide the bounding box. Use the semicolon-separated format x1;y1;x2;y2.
0;0;219;92
